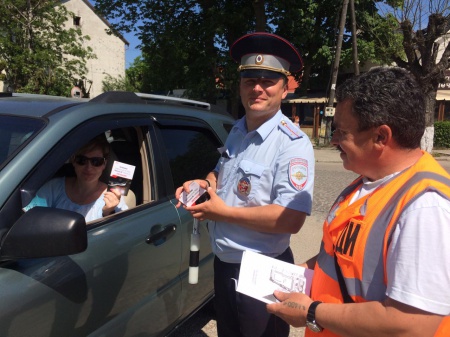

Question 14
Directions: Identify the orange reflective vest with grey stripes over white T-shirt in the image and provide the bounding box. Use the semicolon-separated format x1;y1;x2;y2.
306;152;450;337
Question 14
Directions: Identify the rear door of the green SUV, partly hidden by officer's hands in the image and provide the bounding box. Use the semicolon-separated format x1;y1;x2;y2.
154;115;223;316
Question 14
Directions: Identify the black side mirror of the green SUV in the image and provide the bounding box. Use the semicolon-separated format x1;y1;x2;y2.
0;207;87;260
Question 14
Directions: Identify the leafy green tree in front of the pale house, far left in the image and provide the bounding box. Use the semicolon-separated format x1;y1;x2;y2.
0;0;95;96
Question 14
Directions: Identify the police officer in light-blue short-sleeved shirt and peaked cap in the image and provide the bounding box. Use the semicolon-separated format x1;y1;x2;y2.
176;33;314;337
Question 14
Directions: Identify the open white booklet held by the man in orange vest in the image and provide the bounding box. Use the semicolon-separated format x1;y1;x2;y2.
236;250;314;303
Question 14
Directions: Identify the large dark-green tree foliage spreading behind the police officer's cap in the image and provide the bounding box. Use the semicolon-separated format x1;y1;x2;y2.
96;0;386;115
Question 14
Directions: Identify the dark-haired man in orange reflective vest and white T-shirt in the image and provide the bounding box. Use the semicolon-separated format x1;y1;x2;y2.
267;67;450;337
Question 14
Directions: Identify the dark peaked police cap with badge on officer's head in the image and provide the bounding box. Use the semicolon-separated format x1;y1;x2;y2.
230;32;303;77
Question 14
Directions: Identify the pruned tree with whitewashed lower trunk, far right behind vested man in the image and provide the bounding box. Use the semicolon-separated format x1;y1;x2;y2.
365;0;450;152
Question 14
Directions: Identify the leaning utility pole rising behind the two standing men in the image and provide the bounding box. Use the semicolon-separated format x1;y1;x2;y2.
324;0;349;145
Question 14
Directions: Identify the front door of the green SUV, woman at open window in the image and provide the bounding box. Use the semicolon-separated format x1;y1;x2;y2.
0;115;184;337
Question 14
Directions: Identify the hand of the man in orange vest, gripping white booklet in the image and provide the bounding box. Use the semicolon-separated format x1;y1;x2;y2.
266;290;313;327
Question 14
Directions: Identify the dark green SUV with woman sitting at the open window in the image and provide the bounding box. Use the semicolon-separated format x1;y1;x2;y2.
0;92;234;337
